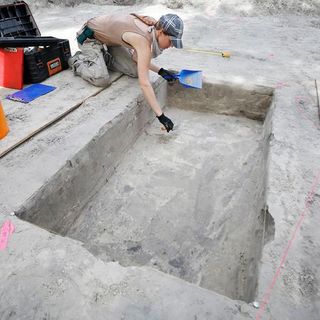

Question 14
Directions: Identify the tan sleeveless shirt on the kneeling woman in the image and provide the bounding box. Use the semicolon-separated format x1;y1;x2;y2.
87;14;152;48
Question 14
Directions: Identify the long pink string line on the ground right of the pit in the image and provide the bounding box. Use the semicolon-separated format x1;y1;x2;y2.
256;172;320;320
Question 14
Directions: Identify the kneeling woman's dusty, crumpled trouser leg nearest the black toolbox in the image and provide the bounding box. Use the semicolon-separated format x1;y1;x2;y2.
68;39;109;87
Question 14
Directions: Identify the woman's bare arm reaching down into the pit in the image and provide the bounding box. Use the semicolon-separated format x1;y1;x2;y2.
122;32;162;116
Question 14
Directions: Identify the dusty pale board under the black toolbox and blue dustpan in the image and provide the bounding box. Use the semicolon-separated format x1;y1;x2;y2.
0;70;122;158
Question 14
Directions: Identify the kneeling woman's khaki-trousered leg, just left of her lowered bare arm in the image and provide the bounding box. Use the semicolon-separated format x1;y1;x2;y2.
108;47;138;78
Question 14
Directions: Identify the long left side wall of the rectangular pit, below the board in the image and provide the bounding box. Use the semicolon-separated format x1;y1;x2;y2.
16;81;166;236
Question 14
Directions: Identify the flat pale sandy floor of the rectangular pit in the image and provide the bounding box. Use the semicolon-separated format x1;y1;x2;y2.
67;108;264;301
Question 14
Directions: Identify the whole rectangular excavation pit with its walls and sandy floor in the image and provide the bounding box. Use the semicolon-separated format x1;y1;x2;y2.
17;82;274;302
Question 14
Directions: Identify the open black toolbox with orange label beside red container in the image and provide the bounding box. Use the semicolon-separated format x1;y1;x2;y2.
0;1;71;83
